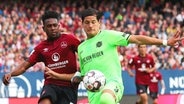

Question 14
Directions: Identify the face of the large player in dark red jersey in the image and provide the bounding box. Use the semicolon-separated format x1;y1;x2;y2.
43;18;59;39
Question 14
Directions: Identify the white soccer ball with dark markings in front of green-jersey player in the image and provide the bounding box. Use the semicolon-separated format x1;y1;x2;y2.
83;70;106;92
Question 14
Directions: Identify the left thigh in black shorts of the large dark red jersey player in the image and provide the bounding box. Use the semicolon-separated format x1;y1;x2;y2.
38;85;57;104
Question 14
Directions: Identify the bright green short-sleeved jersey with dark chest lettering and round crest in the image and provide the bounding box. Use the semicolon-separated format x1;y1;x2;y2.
78;30;130;84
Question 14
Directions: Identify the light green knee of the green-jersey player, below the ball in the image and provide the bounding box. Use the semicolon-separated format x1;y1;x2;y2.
100;93;116;104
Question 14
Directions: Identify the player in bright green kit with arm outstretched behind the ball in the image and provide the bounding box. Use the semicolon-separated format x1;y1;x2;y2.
71;8;184;104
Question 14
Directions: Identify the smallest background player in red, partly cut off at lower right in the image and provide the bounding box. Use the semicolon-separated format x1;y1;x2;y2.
149;70;165;104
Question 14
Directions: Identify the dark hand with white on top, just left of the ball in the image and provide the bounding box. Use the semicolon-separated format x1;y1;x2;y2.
71;71;82;84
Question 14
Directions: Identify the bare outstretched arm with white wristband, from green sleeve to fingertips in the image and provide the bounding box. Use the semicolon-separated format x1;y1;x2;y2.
129;31;184;46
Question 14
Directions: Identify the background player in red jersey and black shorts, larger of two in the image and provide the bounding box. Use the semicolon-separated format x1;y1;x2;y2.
128;45;156;104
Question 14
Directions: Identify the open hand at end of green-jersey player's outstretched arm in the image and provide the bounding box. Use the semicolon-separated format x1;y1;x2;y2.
167;31;184;46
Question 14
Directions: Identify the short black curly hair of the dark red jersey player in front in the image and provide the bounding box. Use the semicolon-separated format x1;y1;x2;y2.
41;11;60;23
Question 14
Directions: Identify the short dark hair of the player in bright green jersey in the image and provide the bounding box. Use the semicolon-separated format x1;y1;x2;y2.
81;8;103;21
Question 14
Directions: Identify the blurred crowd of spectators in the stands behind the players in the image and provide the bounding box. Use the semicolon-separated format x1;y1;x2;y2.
0;0;184;72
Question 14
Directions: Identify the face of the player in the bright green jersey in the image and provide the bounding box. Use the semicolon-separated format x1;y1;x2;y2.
83;16;100;38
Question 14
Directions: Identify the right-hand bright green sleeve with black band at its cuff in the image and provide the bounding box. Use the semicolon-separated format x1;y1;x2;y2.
106;30;130;46
